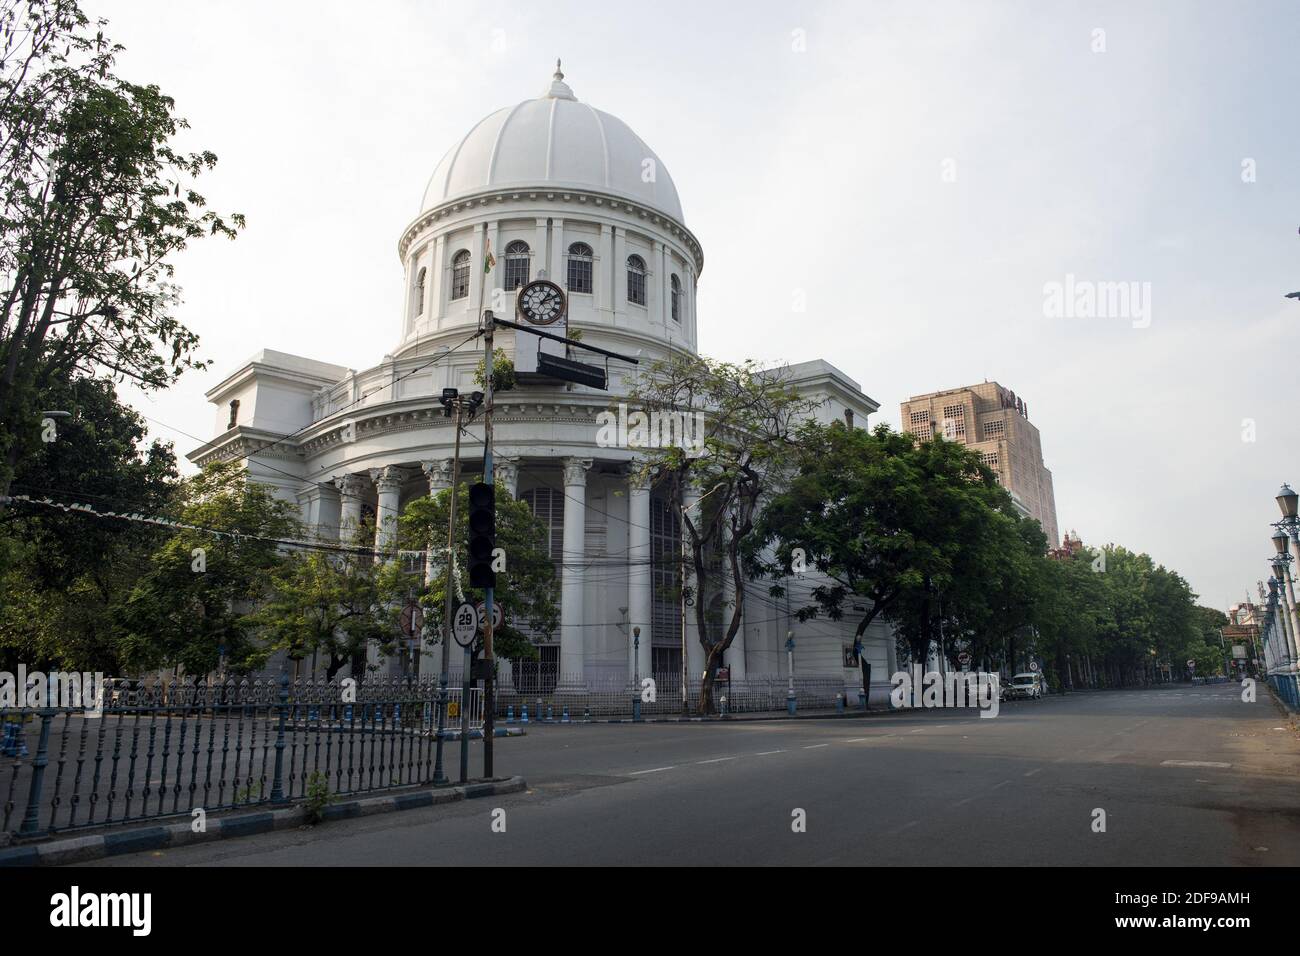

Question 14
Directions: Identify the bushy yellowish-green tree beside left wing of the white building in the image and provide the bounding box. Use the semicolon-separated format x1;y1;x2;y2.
120;462;299;675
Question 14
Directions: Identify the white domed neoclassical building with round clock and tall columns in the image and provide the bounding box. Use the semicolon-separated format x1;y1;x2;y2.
190;66;894;700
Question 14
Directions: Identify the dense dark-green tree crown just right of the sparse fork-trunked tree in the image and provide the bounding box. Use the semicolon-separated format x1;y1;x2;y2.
750;423;1045;661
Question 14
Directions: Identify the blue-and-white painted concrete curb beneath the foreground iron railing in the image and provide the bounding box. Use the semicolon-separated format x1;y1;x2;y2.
0;777;528;866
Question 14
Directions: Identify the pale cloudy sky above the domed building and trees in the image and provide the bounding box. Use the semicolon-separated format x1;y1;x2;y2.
86;0;1300;609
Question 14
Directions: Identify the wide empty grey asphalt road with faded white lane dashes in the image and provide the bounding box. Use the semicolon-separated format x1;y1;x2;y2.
89;685;1300;866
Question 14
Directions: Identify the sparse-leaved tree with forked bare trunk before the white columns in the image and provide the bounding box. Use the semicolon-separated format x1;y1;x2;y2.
628;355;820;713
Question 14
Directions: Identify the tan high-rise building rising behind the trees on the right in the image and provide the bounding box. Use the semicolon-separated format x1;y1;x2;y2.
902;381;1058;548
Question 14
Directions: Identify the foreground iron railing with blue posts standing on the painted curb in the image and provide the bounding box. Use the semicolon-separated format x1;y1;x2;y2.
0;678;452;836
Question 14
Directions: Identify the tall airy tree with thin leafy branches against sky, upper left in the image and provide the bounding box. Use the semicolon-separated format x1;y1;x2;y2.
0;0;243;504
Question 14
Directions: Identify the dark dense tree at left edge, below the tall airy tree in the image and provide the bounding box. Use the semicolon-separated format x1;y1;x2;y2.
0;369;177;674
